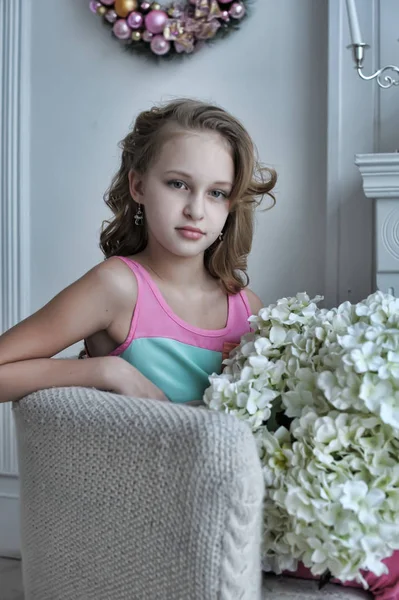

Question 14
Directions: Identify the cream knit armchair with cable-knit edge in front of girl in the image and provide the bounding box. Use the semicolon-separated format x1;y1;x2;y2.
14;388;374;600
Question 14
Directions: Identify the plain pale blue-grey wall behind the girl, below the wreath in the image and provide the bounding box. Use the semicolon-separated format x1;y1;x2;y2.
31;0;327;311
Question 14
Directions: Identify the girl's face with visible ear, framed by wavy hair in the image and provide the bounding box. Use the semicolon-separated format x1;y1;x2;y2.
129;131;234;257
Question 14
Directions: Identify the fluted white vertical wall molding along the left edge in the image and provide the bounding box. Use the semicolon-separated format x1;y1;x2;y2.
0;0;30;475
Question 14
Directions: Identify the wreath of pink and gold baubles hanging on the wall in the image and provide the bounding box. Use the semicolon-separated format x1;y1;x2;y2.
90;0;250;57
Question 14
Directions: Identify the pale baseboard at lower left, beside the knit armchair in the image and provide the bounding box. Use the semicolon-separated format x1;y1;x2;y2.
0;474;21;558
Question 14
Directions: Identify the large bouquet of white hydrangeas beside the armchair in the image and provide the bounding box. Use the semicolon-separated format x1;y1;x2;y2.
204;292;399;587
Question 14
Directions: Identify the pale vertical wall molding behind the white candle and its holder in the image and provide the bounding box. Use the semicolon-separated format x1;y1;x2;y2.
324;0;381;306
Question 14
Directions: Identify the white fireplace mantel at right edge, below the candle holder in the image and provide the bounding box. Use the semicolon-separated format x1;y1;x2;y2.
355;152;399;296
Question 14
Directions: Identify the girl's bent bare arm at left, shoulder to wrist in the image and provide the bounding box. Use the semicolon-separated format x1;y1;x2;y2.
0;259;137;402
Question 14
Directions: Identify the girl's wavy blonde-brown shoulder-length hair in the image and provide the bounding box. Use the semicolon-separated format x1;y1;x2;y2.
100;98;277;294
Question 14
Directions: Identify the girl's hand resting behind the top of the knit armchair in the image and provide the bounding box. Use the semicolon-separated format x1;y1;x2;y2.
103;356;169;402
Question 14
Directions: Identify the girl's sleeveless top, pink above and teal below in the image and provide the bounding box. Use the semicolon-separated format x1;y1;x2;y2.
97;256;251;403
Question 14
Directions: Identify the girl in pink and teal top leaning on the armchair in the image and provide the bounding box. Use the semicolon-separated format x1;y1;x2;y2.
0;99;276;403
